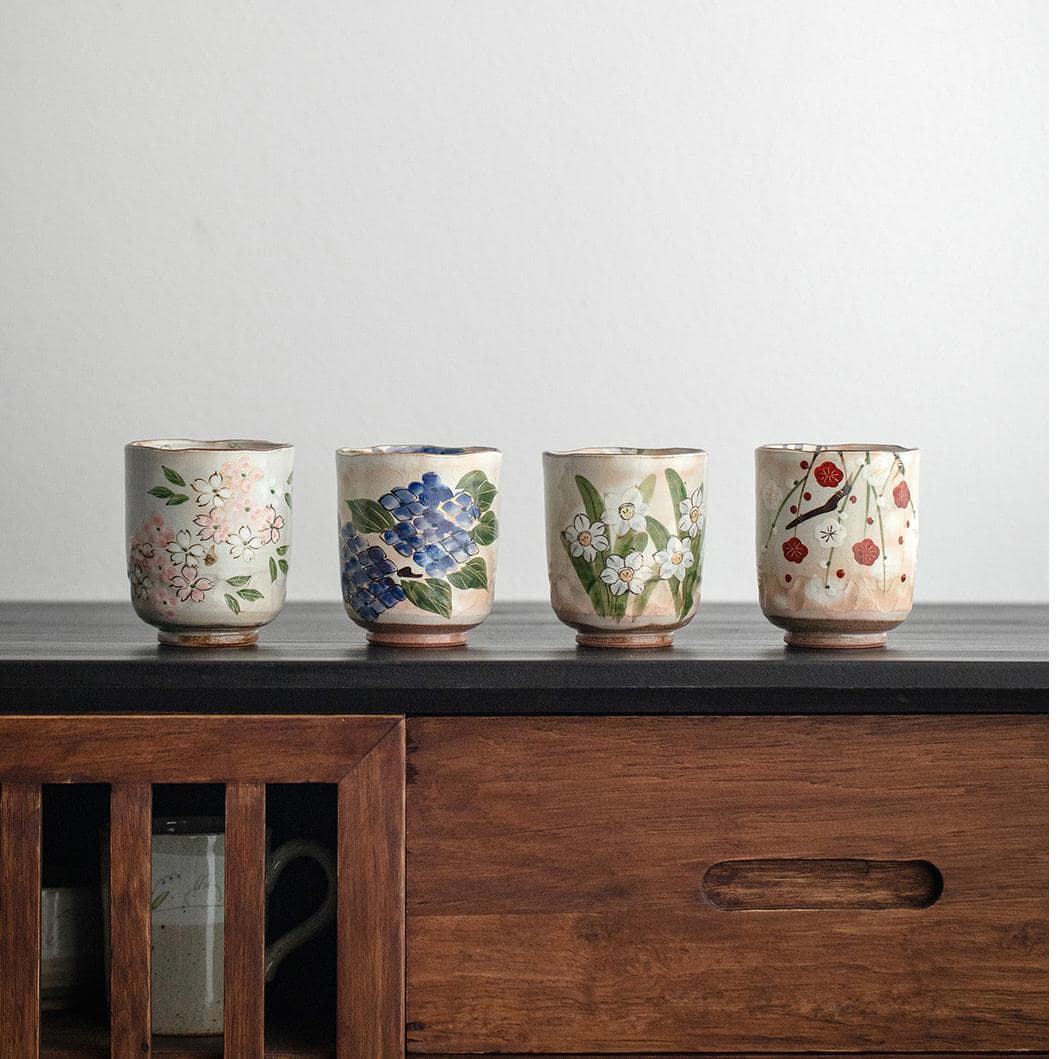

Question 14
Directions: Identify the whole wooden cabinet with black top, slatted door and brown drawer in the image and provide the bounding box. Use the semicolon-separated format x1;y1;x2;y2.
0;605;1047;1059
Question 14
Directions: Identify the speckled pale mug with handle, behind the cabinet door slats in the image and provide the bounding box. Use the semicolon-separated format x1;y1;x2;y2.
103;816;336;1037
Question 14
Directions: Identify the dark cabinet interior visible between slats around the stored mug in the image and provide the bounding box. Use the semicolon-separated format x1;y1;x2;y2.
41;784;338;1059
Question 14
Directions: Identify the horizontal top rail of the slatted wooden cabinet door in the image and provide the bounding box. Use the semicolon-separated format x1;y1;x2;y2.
0;714;395;784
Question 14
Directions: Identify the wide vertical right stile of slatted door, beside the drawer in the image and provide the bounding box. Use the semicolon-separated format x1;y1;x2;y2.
337;721;405;1059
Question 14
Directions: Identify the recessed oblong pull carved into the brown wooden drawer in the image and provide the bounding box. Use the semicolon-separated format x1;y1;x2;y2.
702;860;945;912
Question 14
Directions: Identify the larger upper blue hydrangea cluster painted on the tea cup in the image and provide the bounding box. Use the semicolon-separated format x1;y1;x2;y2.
379;471;482;577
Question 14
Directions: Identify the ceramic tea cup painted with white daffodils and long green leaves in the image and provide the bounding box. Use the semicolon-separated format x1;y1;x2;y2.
544;448;706;647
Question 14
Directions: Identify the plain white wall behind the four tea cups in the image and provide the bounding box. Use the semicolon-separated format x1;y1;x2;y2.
0;0;1047;599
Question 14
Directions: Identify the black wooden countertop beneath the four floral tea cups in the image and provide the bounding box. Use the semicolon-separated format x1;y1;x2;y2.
0;603;1047;714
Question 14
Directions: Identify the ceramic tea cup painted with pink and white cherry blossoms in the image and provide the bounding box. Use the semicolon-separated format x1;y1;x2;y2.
125;439;294;647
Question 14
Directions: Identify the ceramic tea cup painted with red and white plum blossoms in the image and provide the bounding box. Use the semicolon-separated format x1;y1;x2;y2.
755;444;919;647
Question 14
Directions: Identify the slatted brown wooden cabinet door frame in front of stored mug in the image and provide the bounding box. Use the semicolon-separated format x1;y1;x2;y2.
0;714;405;1059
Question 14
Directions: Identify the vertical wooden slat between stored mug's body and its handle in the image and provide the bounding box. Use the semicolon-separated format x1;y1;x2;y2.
225;784;265;1059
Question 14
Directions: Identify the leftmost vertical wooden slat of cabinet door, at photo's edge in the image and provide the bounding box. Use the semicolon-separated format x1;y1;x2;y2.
0;783;40;1059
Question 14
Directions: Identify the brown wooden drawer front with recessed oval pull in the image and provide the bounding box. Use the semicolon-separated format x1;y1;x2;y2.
407;716;1047;1053
